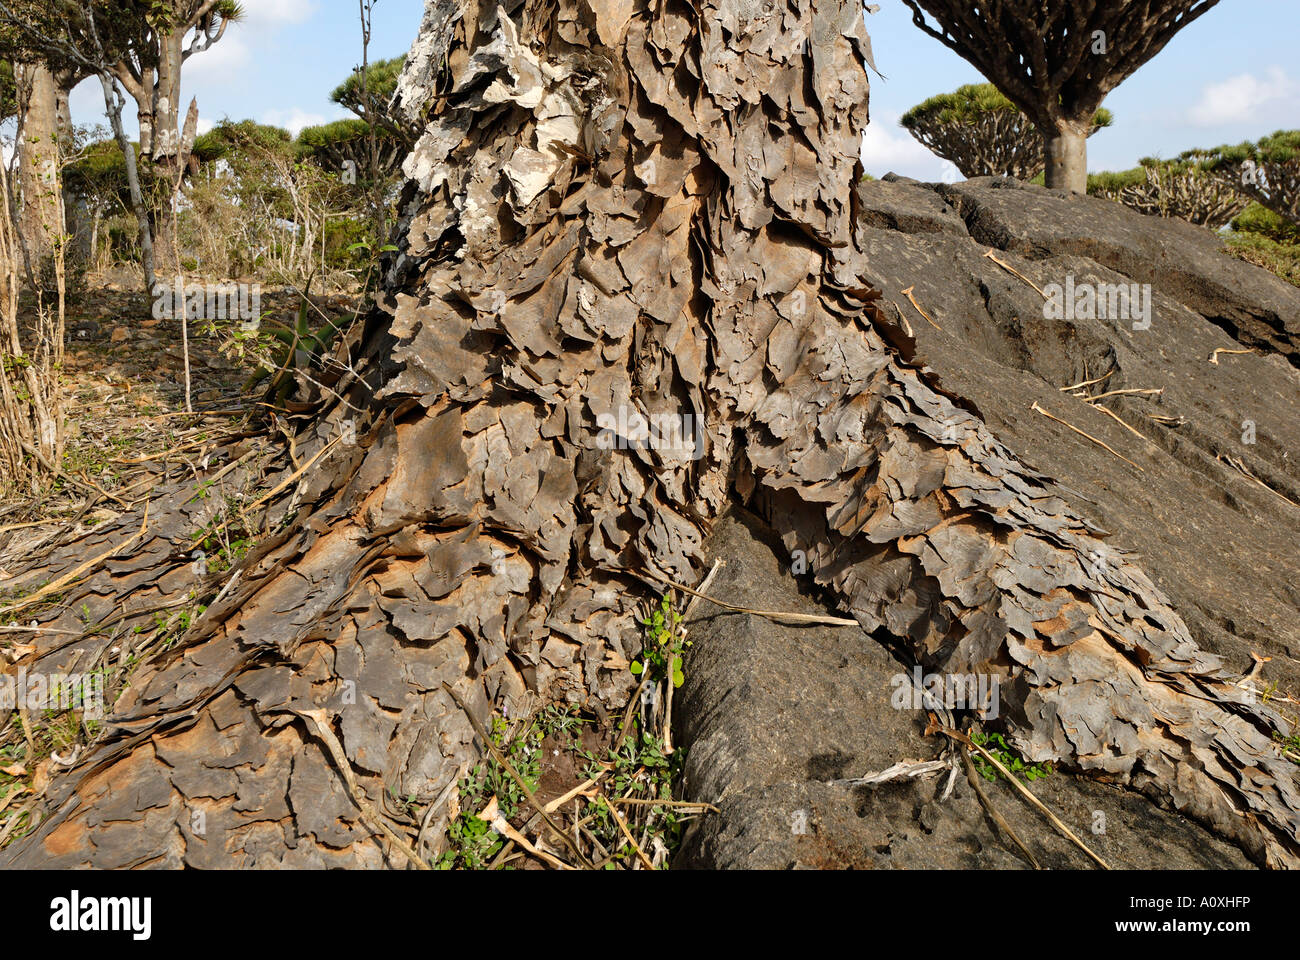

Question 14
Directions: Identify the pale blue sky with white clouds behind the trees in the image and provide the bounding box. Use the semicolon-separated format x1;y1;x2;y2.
65;0;1300;180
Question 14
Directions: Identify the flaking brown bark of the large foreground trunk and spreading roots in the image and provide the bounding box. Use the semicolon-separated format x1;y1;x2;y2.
0;0;1300;868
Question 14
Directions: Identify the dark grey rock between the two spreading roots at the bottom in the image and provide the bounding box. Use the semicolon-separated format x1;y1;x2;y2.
675;509;1249;869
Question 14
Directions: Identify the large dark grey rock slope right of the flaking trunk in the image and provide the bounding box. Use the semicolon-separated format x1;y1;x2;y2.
858;178;1300;697
